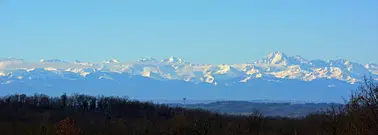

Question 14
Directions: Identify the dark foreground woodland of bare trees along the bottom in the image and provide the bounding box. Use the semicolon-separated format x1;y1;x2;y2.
0;80;378;135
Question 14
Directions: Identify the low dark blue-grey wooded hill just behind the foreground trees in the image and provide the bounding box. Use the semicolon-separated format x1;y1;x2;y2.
168;101;343;117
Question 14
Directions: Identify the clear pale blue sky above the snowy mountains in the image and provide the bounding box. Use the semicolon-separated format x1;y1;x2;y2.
0;0;378;64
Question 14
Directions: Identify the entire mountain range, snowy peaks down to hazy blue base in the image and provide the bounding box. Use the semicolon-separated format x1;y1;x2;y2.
0;52;378;102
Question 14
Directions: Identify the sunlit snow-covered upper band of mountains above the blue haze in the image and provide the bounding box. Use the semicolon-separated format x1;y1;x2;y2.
0;52;378;84
